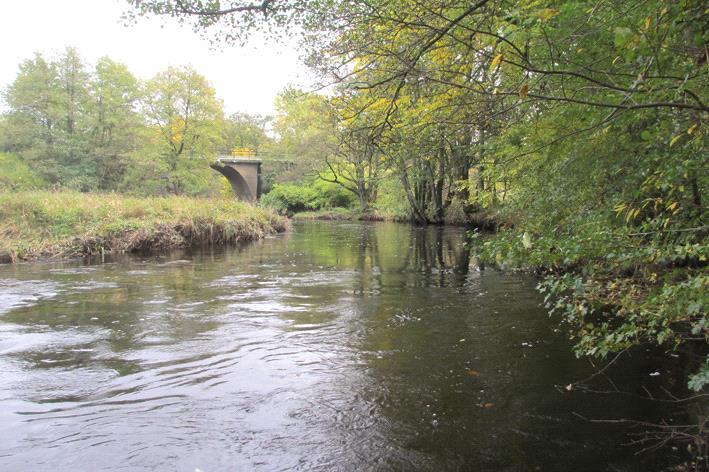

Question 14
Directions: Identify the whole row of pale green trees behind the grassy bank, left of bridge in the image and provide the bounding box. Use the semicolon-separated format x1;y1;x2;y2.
0;48;270;195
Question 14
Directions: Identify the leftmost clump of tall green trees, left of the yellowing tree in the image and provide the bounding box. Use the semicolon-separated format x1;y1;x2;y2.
0;48;145;190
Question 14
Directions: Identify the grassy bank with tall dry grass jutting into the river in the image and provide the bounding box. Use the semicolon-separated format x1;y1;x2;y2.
0;191;288;262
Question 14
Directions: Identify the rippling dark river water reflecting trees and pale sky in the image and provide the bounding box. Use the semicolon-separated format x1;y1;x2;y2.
0;222;688;472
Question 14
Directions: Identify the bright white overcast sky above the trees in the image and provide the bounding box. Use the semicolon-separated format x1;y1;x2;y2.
0;0;308;114
